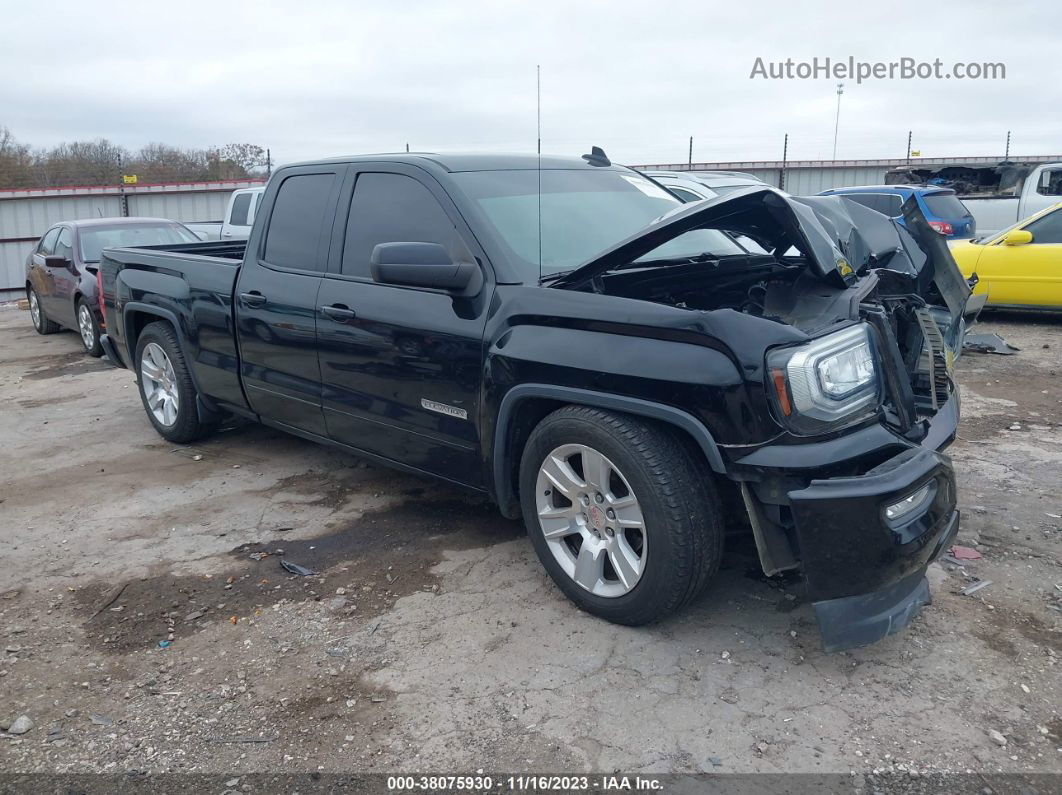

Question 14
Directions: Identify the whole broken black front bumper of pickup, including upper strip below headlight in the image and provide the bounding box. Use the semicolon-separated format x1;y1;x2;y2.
730;394;959;652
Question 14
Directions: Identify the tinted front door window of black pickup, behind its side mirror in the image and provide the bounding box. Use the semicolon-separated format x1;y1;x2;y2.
342;174;463;278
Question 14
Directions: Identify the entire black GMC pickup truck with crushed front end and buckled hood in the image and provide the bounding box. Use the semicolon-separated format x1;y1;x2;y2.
102;150;971;650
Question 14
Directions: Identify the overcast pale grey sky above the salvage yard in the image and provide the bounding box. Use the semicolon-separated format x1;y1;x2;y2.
0;0;1062;163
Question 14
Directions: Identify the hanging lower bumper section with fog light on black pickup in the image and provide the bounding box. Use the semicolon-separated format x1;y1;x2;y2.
788;448;959;652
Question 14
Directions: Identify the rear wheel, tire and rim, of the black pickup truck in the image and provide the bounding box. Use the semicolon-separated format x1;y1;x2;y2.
136;323;216;444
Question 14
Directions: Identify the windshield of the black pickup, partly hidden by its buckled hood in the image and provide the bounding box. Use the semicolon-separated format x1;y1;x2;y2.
453;169;746;281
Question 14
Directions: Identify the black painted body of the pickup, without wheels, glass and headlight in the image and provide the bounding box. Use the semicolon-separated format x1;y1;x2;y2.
103;155;958;649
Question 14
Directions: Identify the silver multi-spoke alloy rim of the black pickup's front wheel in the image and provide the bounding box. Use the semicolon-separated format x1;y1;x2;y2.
535;444;648;599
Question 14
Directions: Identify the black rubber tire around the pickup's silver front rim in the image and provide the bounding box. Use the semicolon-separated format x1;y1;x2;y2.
519;405;723;626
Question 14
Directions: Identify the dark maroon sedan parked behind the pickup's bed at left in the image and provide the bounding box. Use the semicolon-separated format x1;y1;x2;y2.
25;218;199;357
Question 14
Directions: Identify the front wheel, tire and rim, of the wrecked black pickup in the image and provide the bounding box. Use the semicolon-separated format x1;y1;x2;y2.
520;405;723;626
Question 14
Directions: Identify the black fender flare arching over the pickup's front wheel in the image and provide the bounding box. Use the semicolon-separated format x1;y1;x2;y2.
493;383;726;518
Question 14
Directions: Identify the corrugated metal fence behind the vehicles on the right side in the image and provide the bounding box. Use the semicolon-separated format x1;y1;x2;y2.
632;155;1062;196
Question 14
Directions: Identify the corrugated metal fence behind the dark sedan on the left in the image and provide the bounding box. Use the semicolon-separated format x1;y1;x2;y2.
0;179;264;298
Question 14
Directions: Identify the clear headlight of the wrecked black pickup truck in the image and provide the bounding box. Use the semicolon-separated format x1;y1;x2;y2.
767;324;879;435
